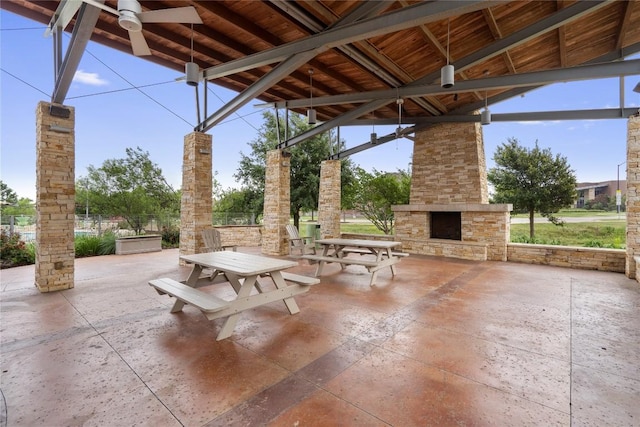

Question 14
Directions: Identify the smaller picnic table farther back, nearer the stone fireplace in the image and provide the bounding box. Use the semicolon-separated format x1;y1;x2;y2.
302;238;408;286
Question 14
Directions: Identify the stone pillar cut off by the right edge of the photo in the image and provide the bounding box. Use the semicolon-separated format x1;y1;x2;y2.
625;115;640;280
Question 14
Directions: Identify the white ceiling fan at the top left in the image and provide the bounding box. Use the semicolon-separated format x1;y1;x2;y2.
82;0;202;56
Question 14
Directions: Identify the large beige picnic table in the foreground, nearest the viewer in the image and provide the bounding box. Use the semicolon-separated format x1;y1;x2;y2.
149;251;320;341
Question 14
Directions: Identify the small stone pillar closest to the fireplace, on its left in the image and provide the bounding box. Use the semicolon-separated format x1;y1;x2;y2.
318;160;342;239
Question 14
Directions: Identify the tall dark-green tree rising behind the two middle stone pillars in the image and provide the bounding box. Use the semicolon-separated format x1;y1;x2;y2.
234;111;353;231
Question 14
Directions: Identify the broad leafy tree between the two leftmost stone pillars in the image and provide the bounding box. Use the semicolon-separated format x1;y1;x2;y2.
76;147;180;234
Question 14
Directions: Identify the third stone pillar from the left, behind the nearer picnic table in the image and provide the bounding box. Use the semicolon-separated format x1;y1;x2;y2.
262;150;291;255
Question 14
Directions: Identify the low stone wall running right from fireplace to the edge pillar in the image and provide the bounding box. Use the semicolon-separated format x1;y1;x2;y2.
507;243;626;273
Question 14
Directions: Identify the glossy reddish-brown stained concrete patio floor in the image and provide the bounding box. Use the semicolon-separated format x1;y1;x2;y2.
0;248;640;426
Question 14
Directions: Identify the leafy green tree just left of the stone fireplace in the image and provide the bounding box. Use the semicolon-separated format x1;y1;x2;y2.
353;168;411;234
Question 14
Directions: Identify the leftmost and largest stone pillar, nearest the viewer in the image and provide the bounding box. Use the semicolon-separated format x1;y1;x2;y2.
35;102;76;292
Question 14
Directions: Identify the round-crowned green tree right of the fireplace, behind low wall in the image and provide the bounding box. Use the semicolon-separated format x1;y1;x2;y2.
487;138;576;241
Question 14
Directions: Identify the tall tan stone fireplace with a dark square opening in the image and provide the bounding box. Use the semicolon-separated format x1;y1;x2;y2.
393;123;512;261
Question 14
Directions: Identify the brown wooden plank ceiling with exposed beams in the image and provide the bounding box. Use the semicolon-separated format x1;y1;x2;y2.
0;0;640;139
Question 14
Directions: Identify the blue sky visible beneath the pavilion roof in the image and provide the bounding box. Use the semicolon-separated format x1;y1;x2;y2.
0;11;640;199
